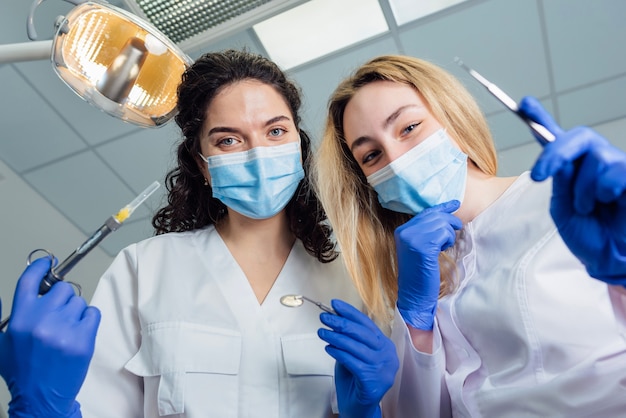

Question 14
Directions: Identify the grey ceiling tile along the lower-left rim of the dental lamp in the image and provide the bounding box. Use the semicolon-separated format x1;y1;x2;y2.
14;61;141;145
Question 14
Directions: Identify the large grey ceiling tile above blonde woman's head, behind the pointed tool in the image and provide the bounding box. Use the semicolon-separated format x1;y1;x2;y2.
400;0;550;112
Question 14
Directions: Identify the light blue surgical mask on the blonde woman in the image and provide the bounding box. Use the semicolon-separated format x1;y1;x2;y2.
367;129;467;215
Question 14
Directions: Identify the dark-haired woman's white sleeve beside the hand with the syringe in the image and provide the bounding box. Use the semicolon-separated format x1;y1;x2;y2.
78;245;144;418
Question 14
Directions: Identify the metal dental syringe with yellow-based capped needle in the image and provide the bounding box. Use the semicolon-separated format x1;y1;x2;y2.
0;181;160;331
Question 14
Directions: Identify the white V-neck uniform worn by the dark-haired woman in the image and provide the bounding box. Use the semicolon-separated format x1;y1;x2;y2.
79;227;361;418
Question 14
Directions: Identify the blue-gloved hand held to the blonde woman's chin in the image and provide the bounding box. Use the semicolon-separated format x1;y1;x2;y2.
395;200;463;330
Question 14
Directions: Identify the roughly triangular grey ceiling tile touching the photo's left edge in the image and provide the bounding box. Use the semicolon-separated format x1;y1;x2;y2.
0;65;86;172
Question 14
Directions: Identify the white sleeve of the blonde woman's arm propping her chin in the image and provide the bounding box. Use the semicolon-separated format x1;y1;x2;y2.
382;308;451;418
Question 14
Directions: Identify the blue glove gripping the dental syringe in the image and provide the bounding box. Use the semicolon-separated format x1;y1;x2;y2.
0;258;100;418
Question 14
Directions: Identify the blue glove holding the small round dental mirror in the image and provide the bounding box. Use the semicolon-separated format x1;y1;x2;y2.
318;299;399;418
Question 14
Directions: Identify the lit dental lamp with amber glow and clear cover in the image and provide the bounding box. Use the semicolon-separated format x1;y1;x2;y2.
27;0;192;127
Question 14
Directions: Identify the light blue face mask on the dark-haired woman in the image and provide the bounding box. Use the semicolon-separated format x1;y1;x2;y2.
201;142;304;219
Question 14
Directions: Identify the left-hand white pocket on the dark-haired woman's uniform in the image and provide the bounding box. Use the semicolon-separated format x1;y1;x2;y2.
125;321;242;416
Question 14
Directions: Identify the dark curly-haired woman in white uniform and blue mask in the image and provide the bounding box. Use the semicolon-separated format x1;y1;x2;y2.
79;51;382;418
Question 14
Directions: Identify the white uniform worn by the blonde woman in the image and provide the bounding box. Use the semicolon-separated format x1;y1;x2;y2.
383;173;626;418
